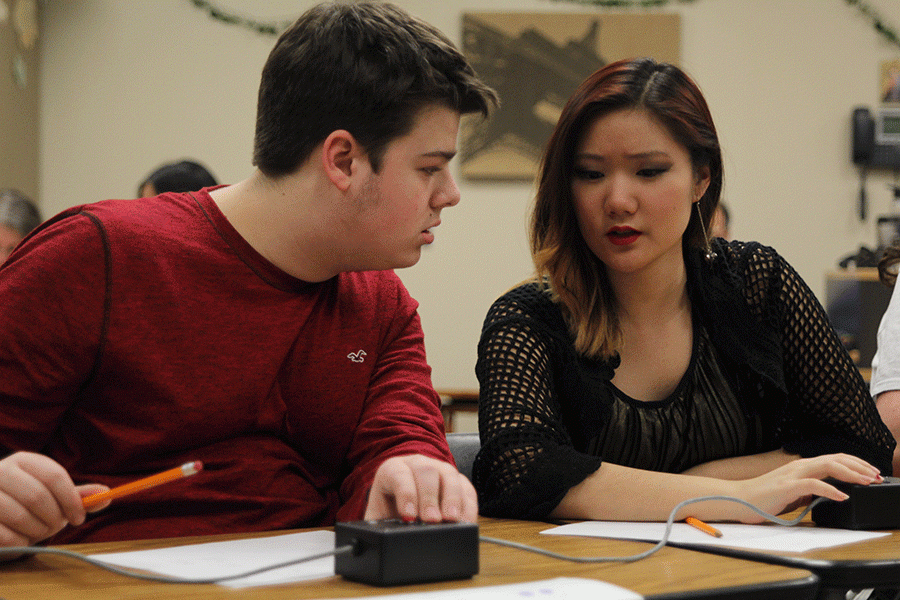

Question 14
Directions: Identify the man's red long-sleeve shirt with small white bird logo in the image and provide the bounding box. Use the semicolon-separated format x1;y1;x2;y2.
0;192;452;543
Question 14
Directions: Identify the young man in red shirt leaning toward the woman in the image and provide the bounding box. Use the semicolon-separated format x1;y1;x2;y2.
0;3;496;545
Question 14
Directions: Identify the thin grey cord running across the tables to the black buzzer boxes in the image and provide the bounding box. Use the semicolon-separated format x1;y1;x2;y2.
0;496;825;584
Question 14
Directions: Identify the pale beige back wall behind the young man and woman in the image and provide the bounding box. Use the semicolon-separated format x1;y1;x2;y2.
40;0;900;387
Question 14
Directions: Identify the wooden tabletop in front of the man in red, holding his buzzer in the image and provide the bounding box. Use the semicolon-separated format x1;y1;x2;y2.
0;519;818;600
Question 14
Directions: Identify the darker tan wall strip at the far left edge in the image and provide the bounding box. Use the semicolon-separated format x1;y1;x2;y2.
0;0;40;203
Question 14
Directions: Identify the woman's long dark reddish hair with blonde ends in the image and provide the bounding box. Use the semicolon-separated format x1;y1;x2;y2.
531;58;722;357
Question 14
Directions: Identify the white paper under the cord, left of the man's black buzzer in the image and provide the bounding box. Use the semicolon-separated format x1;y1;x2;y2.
91;531;334;588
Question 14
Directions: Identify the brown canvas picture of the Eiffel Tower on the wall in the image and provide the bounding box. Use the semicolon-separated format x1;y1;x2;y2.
460;12;681;180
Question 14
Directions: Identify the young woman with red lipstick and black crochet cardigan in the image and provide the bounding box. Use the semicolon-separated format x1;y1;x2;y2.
474;59;894;522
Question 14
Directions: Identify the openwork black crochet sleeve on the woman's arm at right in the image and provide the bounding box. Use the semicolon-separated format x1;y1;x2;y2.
746;250;894;473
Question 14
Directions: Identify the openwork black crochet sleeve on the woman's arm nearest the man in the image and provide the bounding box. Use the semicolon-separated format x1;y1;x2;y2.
473;288;600;519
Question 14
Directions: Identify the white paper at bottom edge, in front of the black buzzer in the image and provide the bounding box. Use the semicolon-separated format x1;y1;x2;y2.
316;577;643;600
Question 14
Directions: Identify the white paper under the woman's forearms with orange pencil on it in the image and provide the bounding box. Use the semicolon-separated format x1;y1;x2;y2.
541;521;890;552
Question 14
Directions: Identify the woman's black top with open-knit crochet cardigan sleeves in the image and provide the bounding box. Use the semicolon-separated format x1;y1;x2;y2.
473;239;894;519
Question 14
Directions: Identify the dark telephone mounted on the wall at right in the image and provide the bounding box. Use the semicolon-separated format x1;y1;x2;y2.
851;107;900;170
